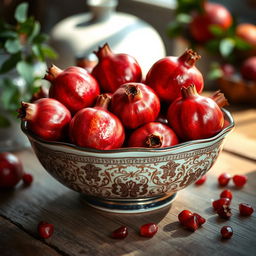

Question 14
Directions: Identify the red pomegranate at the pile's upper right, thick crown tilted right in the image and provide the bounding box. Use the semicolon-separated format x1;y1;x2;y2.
145;50;204;102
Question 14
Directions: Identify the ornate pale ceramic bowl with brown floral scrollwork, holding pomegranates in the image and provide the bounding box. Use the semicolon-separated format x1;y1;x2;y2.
21;109;234;213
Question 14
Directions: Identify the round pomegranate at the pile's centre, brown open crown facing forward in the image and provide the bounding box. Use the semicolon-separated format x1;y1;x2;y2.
111;83;160;129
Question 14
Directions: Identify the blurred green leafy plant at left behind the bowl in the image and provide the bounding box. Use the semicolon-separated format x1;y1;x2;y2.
0;2;57;151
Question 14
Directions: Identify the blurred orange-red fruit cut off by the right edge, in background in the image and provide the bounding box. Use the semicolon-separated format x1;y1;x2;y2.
235;23;256;49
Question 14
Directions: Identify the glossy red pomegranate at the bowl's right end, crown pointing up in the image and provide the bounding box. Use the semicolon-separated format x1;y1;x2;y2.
167;85;226;141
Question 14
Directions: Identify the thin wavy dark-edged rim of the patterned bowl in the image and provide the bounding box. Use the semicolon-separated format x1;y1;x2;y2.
21;108;235;154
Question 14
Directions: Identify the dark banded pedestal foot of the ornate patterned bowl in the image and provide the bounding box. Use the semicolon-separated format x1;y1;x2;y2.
82;192;177;213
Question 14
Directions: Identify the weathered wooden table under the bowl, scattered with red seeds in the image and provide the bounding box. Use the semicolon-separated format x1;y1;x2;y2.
0;105;256;256
